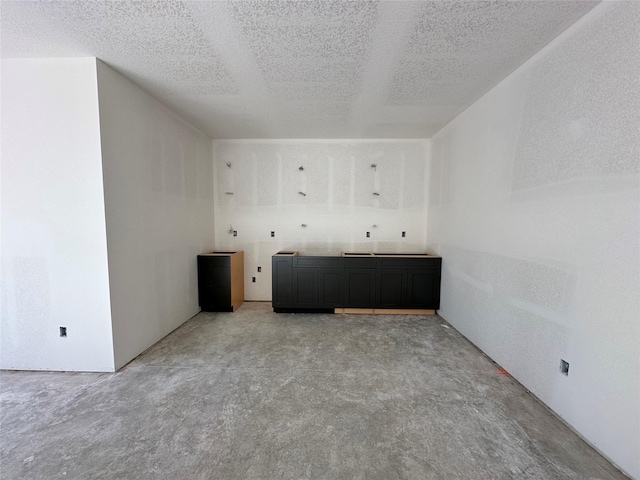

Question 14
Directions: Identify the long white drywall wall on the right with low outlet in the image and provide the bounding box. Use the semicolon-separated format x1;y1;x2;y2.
428;2;640;478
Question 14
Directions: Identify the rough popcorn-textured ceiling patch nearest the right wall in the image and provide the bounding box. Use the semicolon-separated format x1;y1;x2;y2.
387;1;604;105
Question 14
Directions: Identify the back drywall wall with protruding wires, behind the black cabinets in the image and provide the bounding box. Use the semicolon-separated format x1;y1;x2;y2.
214;140;429;301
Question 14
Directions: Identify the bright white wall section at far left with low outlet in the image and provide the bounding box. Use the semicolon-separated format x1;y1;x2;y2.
0;58;114;371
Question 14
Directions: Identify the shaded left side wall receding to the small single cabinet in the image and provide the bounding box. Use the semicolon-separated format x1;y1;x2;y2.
98;61;213;368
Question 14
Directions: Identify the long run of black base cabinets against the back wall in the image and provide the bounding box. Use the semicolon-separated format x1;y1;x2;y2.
272;252;442;312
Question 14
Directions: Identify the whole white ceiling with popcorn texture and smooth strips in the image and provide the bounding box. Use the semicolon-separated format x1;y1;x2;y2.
0;0;598;138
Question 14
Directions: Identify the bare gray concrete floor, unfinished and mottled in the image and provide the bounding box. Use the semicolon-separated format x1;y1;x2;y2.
0;303;627;480
